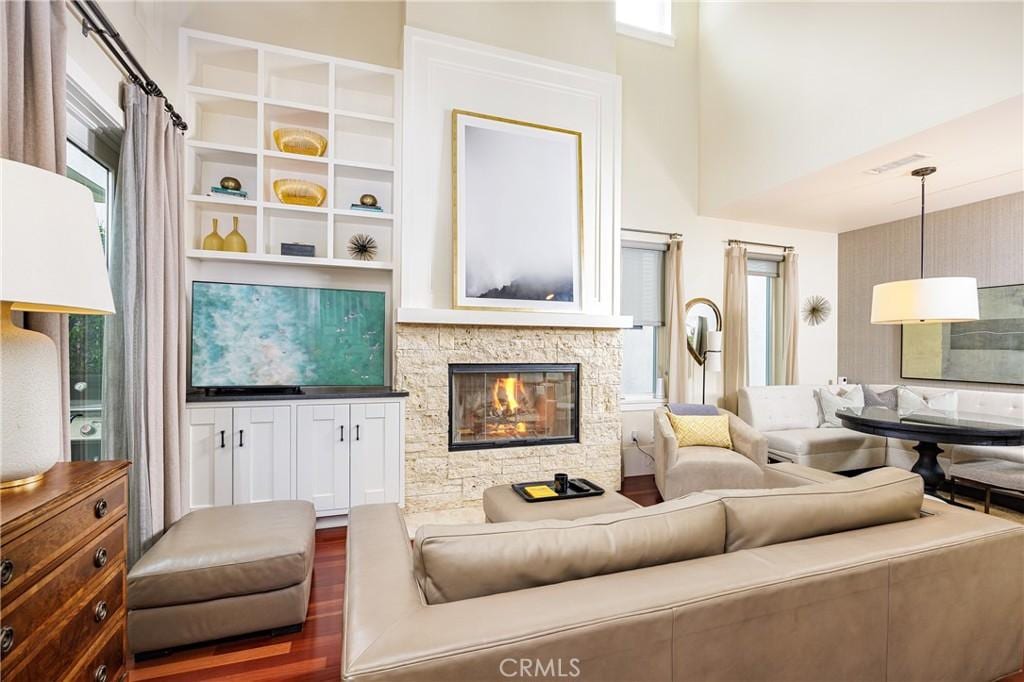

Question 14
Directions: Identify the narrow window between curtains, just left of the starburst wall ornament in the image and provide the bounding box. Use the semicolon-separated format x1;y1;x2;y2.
746;256;778;386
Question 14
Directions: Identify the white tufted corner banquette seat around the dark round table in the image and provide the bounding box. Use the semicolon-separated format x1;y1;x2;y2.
738;385;1024;472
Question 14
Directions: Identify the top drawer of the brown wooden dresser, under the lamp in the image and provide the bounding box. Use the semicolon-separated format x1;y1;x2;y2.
0;477;128;602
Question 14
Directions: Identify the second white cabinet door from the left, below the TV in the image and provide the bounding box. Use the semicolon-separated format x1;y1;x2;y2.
231;406;294;505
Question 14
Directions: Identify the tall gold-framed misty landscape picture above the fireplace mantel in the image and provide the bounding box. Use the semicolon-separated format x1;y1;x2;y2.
452;110;584;312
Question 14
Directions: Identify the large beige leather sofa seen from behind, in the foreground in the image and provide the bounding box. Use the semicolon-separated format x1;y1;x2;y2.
343;464;1024;682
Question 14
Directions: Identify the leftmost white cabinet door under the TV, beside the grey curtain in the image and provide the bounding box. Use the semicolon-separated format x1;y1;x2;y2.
185;408;231;511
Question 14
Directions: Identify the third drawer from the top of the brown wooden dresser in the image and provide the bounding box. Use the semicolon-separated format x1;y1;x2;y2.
3;564;125;682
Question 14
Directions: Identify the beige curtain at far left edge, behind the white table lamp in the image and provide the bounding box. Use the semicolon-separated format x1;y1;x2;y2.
0;0;71;460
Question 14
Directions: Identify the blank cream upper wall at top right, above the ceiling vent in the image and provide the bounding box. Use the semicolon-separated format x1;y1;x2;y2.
700;1;1024;215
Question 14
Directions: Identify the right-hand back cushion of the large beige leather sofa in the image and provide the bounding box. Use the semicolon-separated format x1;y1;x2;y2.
708;467;924;552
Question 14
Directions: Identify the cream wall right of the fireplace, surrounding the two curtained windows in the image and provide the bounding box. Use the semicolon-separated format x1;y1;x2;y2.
615;2;838;475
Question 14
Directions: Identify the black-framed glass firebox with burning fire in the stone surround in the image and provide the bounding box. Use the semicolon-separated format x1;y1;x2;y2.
449;364;580;451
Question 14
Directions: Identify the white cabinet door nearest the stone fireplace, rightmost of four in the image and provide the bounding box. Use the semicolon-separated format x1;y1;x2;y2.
350;402;401;507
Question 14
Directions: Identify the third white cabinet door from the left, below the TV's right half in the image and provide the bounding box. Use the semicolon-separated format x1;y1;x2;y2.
295;404;352;511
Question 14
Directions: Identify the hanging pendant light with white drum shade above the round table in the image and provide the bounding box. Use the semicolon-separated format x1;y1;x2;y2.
871;166;978;325
